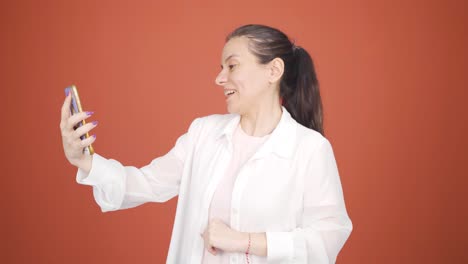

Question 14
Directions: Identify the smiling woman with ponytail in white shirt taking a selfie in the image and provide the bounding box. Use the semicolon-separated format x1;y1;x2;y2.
61;25;352;263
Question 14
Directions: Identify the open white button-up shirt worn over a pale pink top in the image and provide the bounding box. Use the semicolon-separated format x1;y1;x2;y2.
76;107;352;264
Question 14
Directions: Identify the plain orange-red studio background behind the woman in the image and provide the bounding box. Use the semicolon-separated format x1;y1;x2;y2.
0;0;468;263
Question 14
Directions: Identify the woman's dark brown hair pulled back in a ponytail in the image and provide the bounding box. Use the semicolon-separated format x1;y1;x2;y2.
226;24;325;136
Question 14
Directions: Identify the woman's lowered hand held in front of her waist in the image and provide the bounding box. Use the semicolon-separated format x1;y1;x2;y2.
200;218;247;255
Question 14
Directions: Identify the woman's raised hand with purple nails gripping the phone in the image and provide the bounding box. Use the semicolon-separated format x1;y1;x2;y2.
60;93;97;172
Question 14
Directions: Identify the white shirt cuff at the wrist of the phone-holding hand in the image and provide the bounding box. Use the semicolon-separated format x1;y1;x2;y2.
76;153;112;186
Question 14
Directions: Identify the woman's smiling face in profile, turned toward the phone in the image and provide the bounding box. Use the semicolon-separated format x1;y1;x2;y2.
216;37;273;114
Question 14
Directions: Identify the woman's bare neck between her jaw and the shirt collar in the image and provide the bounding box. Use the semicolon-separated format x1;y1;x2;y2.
240;101;283;137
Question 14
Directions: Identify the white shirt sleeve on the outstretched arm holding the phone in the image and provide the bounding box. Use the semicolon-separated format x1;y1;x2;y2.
76;118;200;212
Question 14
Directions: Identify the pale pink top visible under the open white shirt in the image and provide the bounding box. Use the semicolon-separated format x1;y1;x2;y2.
202;122;270;264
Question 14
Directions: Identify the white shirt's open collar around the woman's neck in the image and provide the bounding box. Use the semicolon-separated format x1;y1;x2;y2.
216;106;297;159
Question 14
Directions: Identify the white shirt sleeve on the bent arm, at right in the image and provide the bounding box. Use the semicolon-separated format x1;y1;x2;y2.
266;138;353;264
